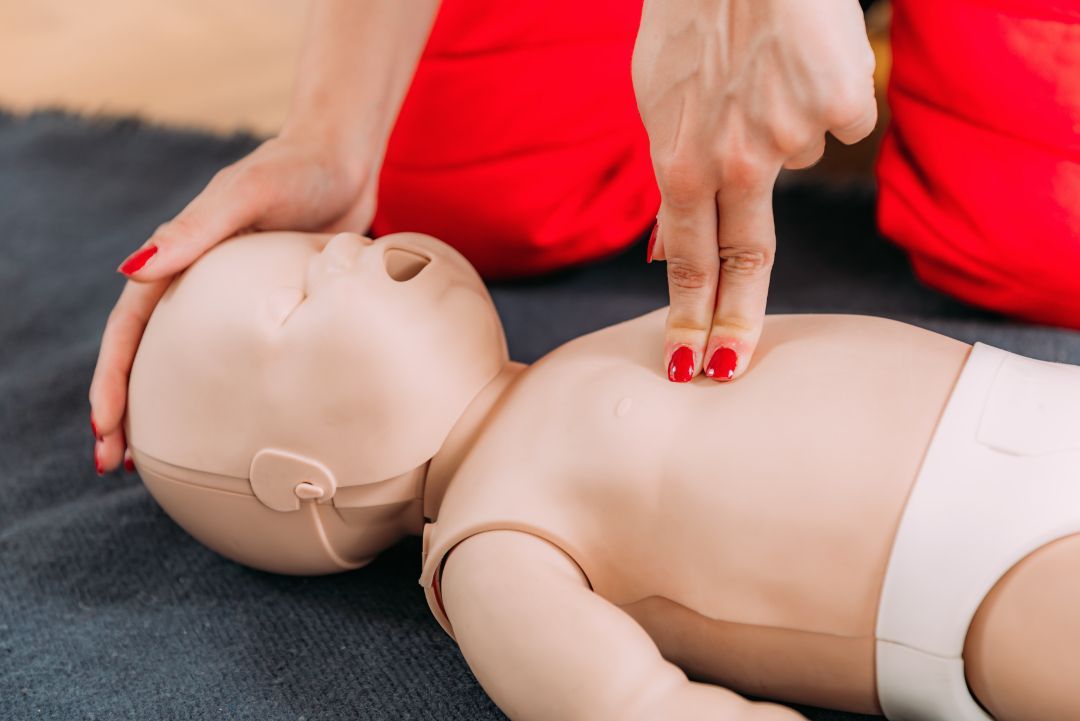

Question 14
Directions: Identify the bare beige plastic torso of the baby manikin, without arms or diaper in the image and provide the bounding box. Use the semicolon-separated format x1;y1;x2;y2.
424;311;969;712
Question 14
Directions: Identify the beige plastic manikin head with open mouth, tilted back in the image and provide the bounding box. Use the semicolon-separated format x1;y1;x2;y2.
126;232;508;574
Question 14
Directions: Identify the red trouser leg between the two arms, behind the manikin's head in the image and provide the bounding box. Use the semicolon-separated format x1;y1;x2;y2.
373;0;660;277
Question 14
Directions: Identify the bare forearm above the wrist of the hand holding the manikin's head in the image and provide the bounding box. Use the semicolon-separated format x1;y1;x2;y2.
282;0;440;158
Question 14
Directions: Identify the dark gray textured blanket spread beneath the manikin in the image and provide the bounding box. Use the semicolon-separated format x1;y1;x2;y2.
0;113;1080;721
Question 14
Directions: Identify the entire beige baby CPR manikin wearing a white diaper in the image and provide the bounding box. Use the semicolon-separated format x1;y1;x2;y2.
126;233;1080;721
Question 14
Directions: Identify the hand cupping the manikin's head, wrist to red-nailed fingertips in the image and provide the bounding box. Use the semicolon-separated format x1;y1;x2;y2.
90;130;375;473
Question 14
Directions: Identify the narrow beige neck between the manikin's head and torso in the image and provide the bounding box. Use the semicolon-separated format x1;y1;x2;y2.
413;361;528;533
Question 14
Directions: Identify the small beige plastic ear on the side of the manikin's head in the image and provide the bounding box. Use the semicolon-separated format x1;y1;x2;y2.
247;448;337;512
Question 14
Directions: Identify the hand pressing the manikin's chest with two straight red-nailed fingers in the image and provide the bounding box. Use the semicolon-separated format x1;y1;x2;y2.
633;0;877;382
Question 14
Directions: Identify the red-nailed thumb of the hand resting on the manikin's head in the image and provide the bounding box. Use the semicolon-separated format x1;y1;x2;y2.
117;166;269;282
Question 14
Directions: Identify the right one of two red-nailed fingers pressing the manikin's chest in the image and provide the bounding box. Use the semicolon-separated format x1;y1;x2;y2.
704;187;777;382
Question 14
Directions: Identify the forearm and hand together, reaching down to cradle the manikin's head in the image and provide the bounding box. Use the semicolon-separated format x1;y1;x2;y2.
90;0;438;474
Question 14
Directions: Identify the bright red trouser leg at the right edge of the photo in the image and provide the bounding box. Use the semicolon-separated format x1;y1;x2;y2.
878;0;1080;328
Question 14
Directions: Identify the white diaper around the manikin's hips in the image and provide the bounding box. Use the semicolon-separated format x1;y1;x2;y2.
877;343;1080;721
